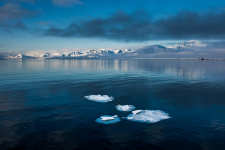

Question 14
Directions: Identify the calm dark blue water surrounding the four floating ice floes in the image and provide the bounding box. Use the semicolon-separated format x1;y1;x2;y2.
0;60;225;150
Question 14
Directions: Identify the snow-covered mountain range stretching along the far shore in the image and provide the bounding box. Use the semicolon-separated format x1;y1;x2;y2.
2;40;210;59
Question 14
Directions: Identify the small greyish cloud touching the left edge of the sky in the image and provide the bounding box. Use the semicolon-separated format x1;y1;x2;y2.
0;3;35;21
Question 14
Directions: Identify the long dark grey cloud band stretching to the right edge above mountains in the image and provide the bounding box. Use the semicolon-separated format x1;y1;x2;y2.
45;11;225;42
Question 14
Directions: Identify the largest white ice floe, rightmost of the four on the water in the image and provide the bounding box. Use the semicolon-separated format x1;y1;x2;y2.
126;110;171;123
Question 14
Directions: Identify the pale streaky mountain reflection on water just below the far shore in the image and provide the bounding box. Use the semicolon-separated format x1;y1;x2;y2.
0;59;225;80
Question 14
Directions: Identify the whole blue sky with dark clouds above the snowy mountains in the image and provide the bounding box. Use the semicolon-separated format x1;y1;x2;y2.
0;0;225;51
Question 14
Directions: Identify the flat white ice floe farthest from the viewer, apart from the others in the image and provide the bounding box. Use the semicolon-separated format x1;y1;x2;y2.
84;94;114;103
